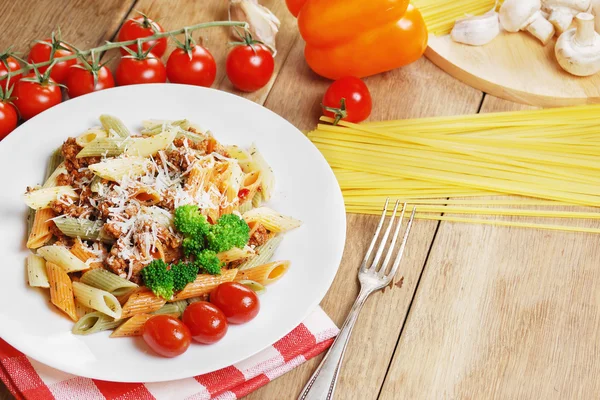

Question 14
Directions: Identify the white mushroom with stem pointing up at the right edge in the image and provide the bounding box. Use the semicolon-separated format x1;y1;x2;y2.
555;13;600;76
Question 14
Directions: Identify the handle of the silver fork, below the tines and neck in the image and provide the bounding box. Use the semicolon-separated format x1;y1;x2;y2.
298;288;372;400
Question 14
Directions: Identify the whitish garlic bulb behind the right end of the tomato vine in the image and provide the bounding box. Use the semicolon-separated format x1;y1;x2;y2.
229;0;281;56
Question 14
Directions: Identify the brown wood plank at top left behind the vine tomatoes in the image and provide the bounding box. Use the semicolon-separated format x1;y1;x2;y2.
0;0;135;400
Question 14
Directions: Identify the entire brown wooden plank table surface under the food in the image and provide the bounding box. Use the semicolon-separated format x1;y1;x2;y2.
0;0;600;400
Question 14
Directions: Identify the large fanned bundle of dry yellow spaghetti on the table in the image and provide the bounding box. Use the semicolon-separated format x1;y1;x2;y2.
308;105;600;233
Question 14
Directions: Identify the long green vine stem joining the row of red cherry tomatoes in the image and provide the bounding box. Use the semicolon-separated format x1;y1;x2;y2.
0;21;248;81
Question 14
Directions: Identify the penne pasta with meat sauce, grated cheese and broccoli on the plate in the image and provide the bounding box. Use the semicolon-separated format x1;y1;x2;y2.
25;115;301;346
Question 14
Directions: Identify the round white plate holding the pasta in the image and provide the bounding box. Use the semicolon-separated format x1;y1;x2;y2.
0;84;346;382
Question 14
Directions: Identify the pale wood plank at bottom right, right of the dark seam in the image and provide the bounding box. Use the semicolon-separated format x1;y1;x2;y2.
381;97;600;399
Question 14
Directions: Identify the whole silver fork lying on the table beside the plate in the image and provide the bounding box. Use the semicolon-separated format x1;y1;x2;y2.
298;198;416;400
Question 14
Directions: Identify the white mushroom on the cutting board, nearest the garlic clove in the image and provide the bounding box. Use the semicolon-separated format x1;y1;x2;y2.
500;0;554;44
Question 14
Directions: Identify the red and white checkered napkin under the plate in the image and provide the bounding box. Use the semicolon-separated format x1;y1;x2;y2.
0;308;338;400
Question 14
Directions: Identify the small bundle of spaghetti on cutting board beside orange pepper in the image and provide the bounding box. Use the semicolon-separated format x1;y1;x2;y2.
412;0;498;36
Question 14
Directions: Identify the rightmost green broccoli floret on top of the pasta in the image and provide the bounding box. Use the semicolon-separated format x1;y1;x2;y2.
206;214;250;253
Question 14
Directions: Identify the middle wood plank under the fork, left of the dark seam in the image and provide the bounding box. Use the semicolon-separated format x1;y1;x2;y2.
248;41;482;400
